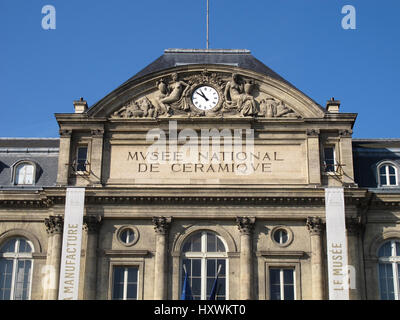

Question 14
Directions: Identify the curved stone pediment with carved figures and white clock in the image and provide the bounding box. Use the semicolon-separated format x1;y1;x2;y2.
88;53;325;120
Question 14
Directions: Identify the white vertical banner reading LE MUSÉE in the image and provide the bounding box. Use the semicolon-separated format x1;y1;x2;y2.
325;188;349;300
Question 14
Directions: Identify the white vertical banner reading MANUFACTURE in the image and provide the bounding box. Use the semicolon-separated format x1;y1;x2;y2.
58;188;85;300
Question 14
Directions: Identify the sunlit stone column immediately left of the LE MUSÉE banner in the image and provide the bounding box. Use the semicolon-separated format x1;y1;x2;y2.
306;217;324;300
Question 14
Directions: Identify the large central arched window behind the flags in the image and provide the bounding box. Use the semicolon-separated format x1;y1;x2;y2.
181;231;227;300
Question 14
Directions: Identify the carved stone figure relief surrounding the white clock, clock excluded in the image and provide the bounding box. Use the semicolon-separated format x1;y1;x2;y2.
111;69;300;119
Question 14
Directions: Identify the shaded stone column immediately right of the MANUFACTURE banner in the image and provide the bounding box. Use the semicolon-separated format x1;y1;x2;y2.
83;215;102;300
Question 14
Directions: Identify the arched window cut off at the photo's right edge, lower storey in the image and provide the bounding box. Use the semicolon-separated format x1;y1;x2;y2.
378;240;400;300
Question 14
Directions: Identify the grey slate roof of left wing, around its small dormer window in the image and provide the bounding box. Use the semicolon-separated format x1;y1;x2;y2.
0;138;60;190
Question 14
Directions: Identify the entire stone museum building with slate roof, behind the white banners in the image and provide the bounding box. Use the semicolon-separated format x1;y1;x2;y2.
0;49;400;300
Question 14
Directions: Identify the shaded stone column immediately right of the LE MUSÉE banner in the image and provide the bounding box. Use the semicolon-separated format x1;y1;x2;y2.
346;218;363;300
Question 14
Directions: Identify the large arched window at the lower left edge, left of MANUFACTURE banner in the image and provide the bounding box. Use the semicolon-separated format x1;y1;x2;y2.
0;238;33;300
